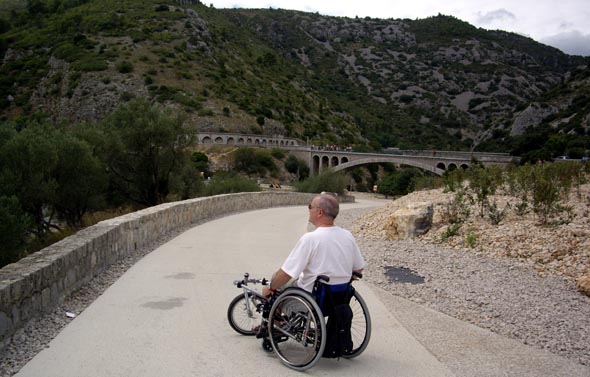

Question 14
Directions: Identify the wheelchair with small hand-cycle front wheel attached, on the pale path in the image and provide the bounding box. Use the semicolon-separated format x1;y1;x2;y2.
227;273;371;371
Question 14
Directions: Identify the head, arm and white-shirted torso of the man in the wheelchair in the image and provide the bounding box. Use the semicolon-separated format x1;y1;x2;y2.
262;194;365;297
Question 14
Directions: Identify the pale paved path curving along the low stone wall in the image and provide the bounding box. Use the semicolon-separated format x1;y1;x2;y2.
18;199;452;377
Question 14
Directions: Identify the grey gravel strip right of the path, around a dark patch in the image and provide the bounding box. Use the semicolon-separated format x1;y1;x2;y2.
338;209;590;366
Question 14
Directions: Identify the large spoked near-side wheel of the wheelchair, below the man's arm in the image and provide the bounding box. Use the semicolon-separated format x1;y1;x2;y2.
268;288;326;371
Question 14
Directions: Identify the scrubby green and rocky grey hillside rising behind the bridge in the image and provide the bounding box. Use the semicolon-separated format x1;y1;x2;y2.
0;0;589;151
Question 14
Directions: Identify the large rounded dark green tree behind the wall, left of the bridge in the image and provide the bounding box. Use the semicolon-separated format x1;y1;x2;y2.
102;99;192;206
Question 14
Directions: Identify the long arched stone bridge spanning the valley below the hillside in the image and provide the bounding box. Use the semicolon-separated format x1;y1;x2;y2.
197;133;514;175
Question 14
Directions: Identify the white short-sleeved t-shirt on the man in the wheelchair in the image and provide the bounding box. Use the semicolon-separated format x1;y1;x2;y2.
281;226;365;292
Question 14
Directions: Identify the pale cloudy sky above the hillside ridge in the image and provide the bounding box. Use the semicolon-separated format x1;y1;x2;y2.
207;0;590;56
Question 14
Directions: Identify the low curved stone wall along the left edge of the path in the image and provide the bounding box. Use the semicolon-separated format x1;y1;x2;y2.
0;192;344;344
